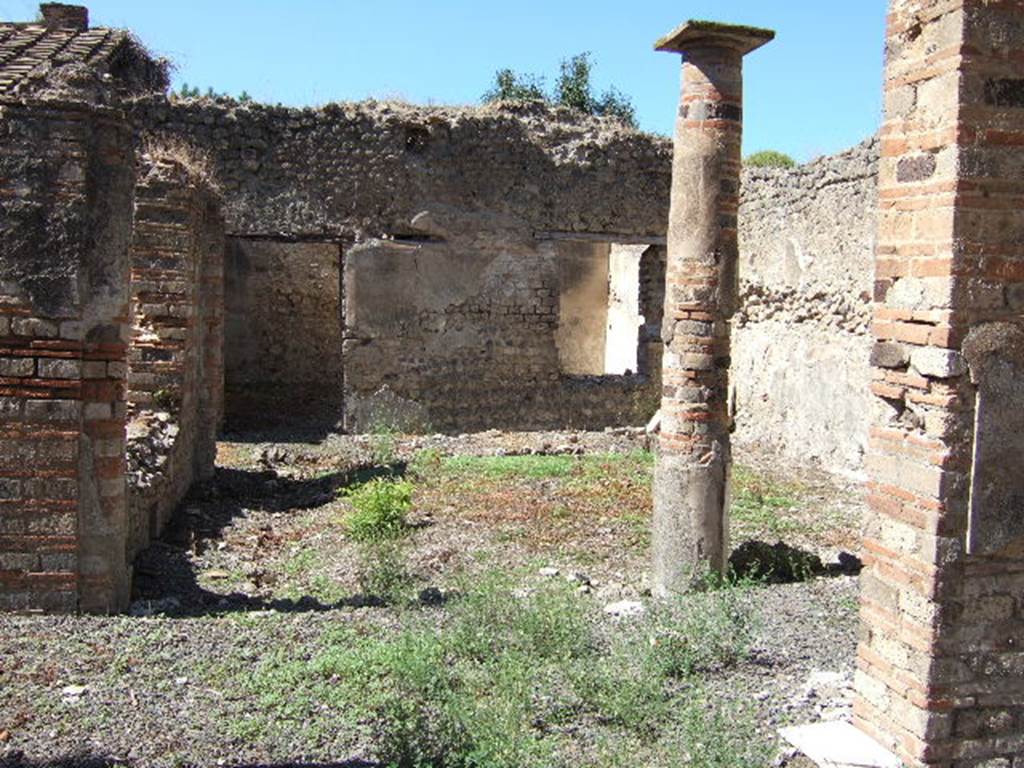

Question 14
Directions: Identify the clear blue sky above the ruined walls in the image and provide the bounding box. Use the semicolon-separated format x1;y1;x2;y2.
0;0;887;161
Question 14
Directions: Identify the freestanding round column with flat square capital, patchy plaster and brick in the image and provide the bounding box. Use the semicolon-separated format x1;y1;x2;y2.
652;22;774;595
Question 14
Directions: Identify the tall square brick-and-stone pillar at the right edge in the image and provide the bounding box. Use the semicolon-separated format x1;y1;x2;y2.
854;0;1024;768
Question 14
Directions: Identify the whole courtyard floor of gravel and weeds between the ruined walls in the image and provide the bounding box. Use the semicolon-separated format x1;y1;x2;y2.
0;430;859;768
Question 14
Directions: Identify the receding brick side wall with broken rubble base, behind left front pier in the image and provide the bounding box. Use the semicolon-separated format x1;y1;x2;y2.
127;155;224;555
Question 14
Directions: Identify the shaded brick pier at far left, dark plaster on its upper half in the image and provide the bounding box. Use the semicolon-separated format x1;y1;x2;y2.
0;100;134;611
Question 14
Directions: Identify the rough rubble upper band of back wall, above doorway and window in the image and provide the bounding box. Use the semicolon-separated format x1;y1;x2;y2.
135;98;671;243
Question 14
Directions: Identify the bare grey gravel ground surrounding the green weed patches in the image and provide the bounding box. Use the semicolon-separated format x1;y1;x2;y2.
0;430;859;766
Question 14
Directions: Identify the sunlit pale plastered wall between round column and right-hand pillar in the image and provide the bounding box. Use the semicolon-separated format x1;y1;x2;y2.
731;140;879;471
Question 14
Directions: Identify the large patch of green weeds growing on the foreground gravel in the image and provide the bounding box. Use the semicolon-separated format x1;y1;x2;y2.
219;572;768;768
